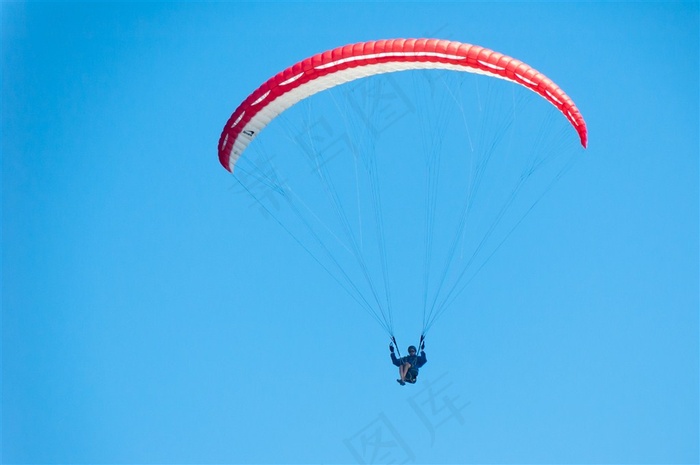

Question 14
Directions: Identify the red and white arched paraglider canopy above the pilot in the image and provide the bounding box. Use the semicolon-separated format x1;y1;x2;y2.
219;39;588;172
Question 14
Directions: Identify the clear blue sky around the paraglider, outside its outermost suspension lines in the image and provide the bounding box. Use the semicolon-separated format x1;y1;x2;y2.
1;2;700;463
